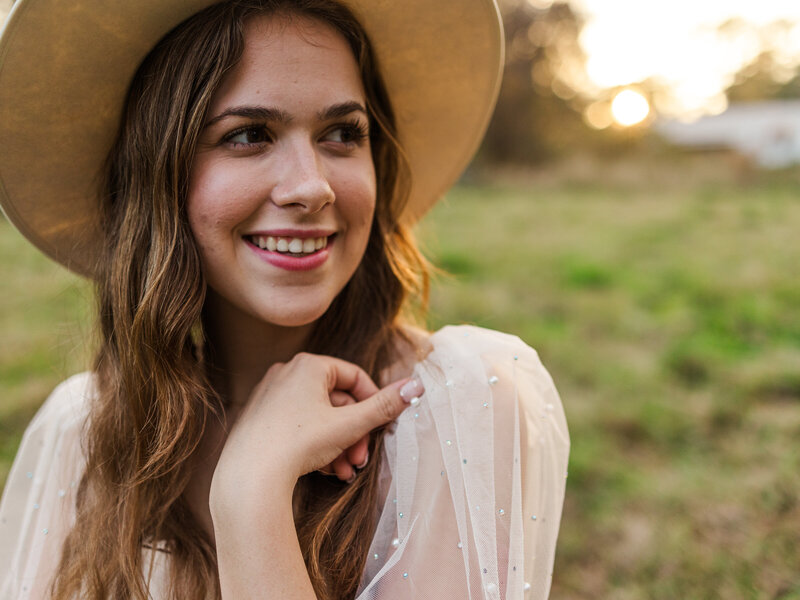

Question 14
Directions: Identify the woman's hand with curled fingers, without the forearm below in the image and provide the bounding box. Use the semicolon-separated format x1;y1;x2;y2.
210;353;424;514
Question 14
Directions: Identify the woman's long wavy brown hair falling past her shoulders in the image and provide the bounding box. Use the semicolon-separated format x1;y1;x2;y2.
52;0;428;600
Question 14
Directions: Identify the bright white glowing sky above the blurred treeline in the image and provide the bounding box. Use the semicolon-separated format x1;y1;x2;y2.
564;0;800;118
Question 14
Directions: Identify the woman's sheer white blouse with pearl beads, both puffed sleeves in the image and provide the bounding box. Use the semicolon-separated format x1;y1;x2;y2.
0;326;569;600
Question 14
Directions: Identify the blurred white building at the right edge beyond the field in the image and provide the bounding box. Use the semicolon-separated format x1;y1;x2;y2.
655;100;800;169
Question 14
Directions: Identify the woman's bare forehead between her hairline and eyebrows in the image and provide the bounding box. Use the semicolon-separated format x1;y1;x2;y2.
210;15;364;114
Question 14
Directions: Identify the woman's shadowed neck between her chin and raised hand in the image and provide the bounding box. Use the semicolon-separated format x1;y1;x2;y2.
203;289;313;406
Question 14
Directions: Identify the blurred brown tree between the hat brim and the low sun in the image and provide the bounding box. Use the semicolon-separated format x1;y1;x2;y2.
479;0;591;165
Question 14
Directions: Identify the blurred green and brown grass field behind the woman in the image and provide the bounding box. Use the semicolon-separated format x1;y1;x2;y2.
0;168;800;600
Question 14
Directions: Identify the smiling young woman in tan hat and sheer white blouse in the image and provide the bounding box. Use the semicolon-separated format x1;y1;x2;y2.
0;0;569;600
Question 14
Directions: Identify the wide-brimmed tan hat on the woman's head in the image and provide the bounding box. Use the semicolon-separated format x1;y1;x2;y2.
0;0;503;275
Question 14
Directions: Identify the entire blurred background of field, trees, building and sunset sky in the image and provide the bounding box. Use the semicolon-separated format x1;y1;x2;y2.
0;0;800;600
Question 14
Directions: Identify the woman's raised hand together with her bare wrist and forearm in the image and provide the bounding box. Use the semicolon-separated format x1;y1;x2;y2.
209;354;423;598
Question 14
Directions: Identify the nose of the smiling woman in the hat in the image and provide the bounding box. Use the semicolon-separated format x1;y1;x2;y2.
272;141;335;213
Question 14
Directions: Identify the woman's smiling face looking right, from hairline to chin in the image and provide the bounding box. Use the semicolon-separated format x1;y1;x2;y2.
187;16;375;326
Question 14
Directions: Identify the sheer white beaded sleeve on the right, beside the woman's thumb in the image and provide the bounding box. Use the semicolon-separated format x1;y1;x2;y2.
358;326;569;600
